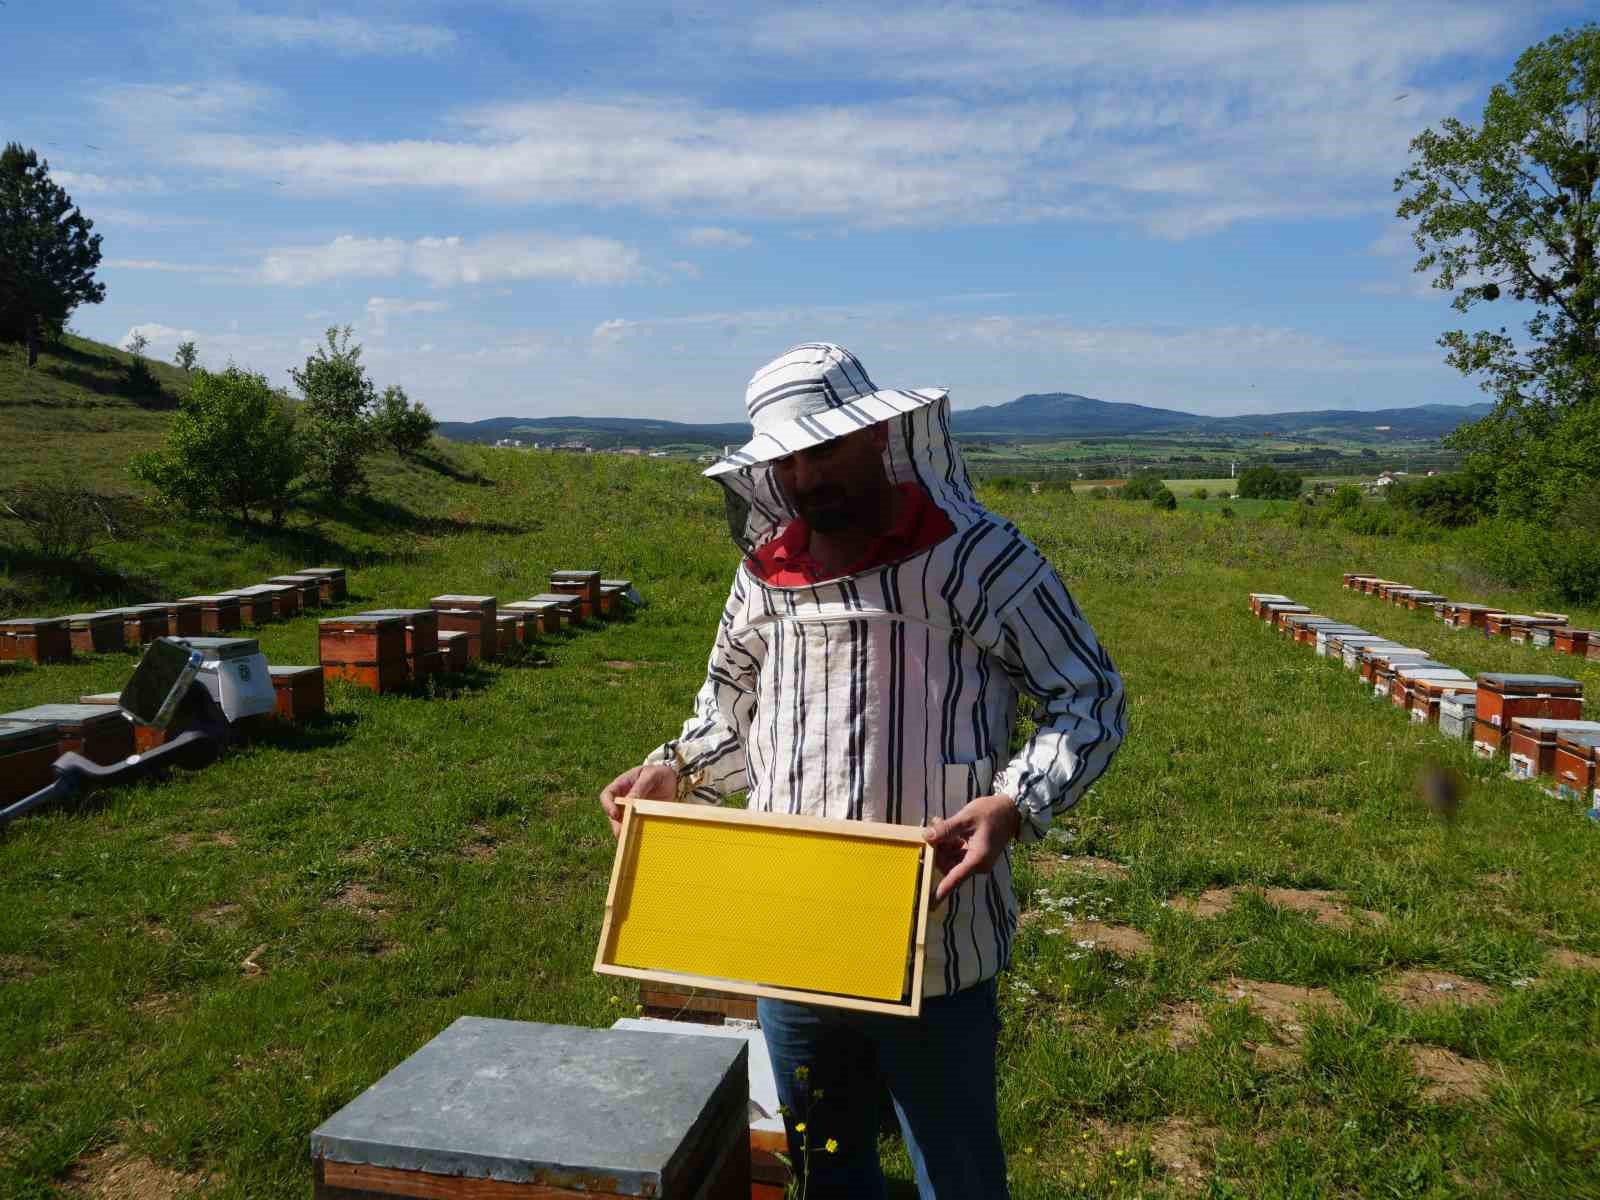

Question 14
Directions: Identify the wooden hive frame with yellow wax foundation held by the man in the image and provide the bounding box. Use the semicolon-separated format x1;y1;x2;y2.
595;802;933;1014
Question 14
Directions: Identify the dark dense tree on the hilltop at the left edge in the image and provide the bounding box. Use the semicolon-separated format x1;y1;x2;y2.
0;142;106;366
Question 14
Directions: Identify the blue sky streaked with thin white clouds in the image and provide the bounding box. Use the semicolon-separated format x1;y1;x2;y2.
0;0;1587;421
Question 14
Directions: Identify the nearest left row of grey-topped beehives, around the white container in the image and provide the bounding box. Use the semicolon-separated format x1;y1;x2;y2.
0;637;326;808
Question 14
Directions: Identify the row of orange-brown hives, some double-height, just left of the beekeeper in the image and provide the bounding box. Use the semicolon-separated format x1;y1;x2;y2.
317;571;632;691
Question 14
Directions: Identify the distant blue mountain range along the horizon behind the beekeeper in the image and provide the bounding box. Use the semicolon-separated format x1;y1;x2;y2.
438;392;1491;450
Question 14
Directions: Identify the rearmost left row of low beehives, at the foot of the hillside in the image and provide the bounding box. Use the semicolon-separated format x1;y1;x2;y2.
0;566;346;664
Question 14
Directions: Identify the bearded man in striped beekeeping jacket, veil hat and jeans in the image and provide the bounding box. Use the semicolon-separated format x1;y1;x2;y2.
600;342;1125;1200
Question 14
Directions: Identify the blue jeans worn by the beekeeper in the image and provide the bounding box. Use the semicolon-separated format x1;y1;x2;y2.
757;979;1008;1200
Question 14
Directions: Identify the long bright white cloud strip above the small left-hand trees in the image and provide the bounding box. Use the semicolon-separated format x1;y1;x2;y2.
259;234;640;288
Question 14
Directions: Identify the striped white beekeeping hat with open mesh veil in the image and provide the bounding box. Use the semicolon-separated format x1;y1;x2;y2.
706;342;982;554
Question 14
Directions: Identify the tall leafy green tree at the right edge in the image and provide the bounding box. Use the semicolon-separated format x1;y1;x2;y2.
1395;24;1600;520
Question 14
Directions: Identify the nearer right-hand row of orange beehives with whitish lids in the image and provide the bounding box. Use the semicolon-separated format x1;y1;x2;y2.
1250;592;1600;810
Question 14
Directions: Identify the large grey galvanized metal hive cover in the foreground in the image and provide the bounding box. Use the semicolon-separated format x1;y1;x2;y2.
310;1016;747;1195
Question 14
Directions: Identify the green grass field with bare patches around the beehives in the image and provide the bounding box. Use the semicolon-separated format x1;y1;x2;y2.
0;340;1600;1200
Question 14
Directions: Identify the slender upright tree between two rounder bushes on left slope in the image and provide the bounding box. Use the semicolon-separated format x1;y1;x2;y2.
290;325;374;499
